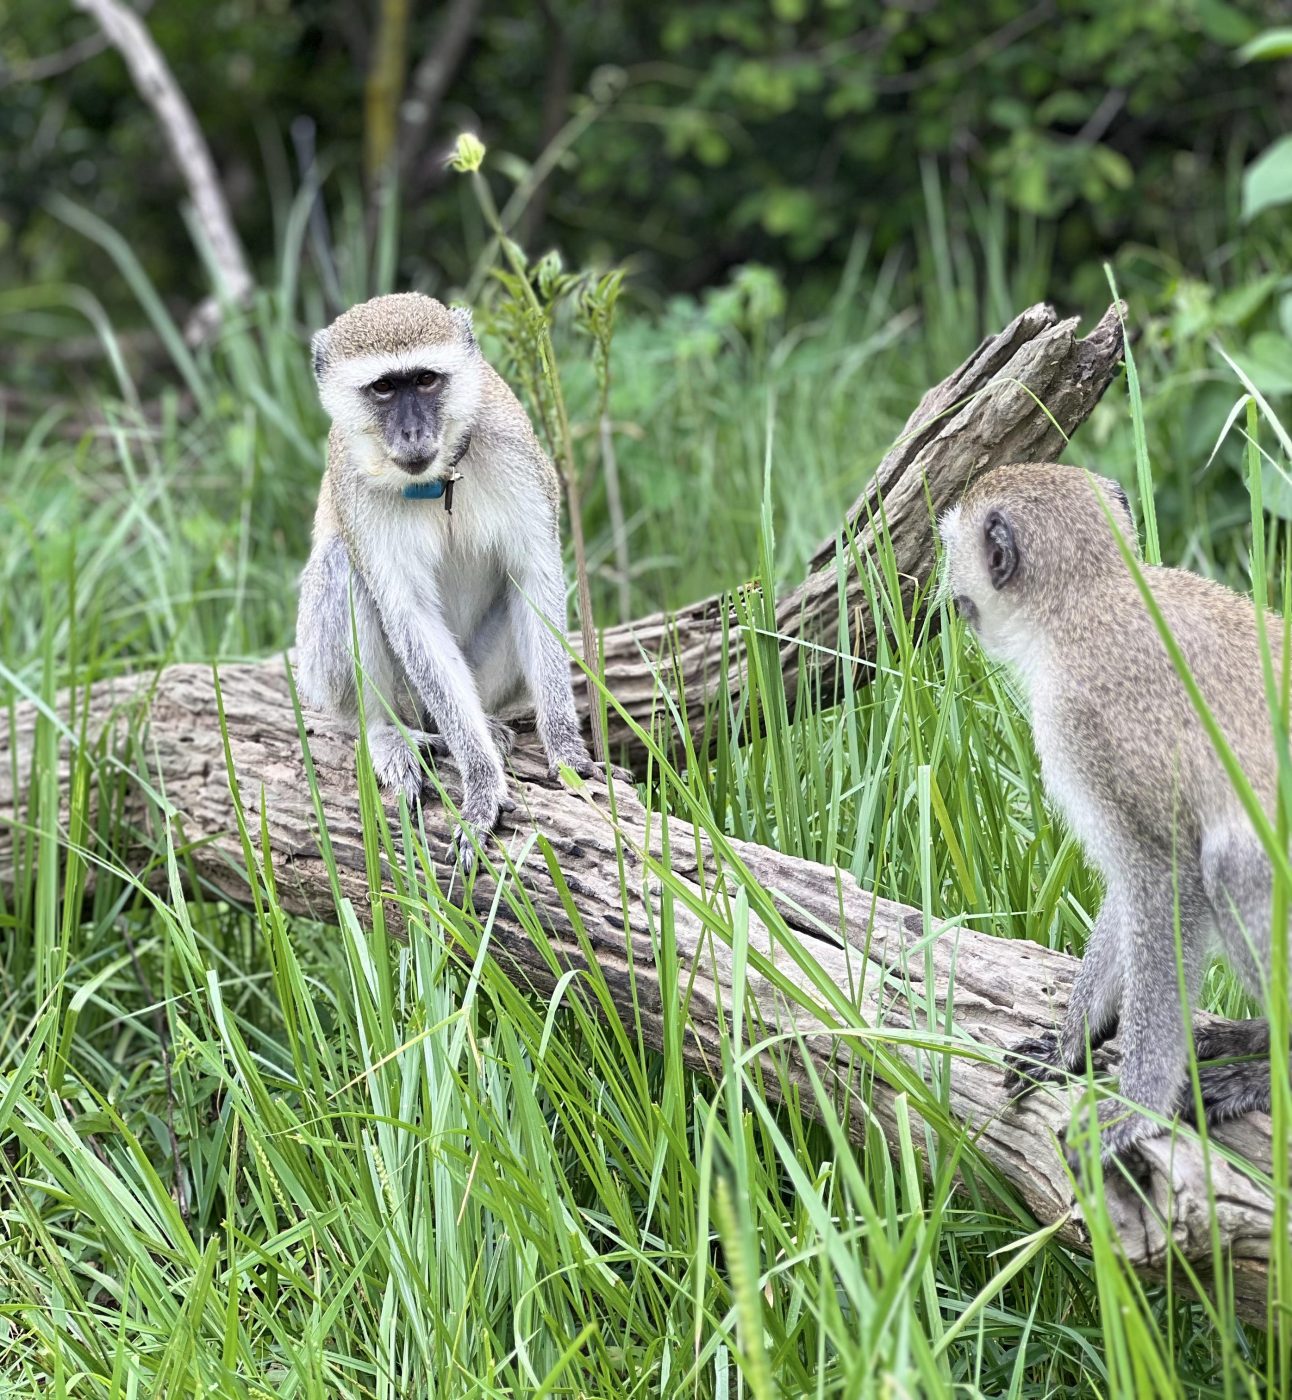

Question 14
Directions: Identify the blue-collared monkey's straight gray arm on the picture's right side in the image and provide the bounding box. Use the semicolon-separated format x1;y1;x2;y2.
507;525;594;777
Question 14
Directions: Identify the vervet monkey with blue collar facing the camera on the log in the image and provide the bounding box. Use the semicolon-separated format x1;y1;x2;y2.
297;293;595;864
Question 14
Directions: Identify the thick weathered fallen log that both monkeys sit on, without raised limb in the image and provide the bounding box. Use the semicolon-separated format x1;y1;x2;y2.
0;661;1274;1324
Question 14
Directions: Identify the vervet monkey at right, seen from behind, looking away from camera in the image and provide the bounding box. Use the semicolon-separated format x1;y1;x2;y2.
941;465;1282;1162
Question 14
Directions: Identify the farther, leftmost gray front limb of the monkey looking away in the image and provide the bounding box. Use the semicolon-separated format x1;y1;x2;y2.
1005;885;1130;1099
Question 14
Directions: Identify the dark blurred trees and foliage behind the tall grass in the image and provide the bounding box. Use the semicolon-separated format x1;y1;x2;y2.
0;0;1292;324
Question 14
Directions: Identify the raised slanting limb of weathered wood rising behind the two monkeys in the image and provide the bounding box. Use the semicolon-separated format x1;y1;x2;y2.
596;305;1121;767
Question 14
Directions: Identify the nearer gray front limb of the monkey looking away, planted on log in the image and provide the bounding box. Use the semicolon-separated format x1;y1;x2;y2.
1068;851;1211;1168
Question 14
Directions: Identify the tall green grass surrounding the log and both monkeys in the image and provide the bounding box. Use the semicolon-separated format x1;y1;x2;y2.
0;210;1292;1397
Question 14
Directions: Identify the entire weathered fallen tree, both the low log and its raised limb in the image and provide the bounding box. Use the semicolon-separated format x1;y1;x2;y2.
0;308;1274;1322
